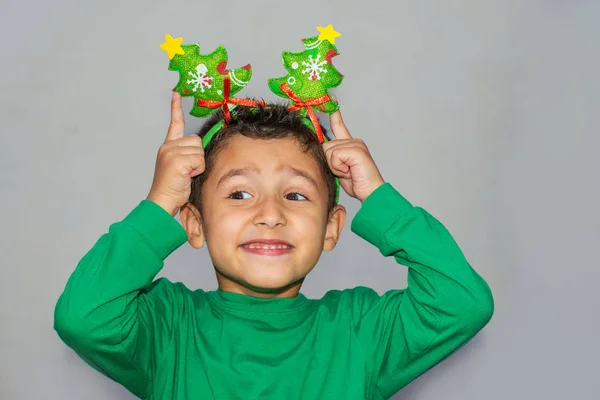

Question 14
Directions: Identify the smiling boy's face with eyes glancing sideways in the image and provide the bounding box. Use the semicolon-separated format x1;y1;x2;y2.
182;134;345;297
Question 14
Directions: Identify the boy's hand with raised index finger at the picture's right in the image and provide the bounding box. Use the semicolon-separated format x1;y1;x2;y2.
323;110;385;202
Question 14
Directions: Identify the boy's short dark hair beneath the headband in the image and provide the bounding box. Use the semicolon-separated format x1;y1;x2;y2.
190;104;336;213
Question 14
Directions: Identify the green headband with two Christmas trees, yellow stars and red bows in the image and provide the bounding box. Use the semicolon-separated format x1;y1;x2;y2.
160;25;344;204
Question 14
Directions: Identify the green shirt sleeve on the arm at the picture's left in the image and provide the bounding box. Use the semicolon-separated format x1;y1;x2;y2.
54;200;186;398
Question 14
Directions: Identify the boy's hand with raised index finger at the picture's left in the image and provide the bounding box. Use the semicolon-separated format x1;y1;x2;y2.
146;92;205;216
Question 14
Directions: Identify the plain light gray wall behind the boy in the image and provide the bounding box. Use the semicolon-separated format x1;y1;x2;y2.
0;0;600;400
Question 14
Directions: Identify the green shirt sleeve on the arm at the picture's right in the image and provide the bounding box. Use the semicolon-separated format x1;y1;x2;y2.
352;183;494;398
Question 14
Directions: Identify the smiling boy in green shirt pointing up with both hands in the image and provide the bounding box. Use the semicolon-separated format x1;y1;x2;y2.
55;94;493;400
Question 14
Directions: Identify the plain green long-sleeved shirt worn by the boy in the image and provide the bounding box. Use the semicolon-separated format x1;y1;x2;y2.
55;183;494;400
